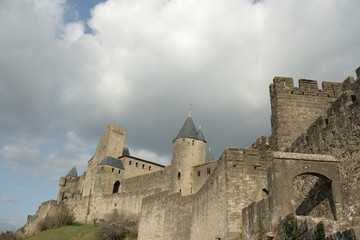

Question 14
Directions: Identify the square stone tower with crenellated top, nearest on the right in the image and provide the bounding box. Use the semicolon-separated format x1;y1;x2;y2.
270;77;349;151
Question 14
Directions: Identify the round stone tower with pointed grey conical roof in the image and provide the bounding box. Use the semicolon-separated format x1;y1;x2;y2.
171;115;206;195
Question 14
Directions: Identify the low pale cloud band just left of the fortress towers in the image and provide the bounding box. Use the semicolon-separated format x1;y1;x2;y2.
0;132;91;178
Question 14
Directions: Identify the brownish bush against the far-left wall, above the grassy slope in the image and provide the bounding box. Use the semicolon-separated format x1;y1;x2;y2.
38;204;75;231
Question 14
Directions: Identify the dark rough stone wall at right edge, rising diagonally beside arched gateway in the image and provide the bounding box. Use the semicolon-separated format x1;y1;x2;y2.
287;68;360;224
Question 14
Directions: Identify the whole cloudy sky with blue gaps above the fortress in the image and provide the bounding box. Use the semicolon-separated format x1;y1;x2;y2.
0;0;360;231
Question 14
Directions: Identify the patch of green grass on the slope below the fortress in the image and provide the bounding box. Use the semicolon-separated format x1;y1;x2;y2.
26;224;96;240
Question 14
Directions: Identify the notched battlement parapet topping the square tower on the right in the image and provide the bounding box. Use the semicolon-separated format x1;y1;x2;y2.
270;77;342;98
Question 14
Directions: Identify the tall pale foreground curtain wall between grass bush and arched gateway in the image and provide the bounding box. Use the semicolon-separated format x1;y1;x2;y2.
139;148;267;240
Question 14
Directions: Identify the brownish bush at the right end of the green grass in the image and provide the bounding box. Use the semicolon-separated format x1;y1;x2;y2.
96;210;136;240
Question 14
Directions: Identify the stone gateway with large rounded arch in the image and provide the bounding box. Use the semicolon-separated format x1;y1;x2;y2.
268;152;343;223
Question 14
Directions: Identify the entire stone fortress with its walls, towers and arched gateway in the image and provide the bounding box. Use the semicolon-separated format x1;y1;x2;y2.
21;68;360;240
